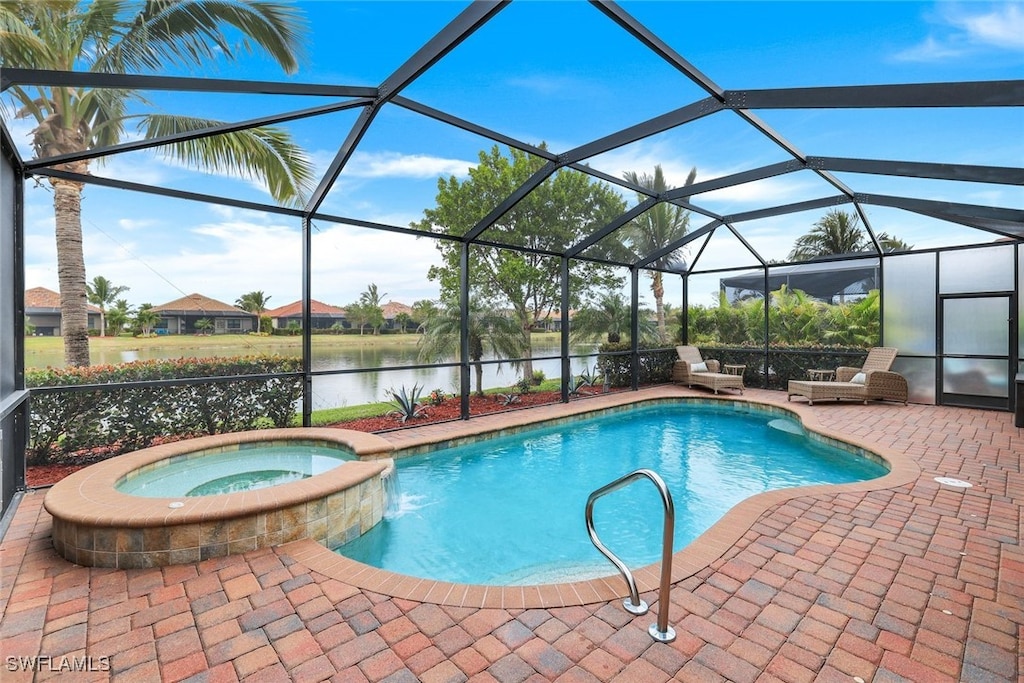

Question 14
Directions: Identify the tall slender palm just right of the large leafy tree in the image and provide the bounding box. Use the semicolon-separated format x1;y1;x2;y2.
623;165;697;344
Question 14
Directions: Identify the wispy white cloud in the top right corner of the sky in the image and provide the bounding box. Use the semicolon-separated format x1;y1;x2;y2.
894;2;1024;61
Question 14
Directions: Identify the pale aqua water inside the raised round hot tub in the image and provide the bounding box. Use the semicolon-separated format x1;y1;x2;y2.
116;442;355;498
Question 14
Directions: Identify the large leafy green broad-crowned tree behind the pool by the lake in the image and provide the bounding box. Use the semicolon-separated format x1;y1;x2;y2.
413;145;625;376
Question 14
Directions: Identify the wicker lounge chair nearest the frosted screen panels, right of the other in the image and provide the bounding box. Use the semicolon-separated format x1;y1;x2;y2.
786;346;908;405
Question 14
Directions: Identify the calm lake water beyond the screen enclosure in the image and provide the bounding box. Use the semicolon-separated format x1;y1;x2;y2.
26;337;598;411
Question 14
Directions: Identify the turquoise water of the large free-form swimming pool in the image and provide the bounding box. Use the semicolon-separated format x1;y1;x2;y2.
337;404;888;586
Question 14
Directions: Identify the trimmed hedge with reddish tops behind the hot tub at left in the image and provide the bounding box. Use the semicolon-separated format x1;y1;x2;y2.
26;356;302;465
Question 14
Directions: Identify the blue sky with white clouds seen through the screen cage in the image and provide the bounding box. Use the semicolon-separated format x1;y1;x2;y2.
8;0;1024;306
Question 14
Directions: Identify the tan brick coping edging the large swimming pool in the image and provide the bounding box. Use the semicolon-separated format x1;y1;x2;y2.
284;386;921;609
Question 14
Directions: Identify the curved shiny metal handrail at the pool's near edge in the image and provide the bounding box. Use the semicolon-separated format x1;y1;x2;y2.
587;469;676;643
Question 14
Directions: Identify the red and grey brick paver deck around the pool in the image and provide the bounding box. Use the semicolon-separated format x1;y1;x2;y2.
0;390;1024;683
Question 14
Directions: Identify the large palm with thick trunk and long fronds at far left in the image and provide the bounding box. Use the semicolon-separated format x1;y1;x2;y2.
0;0;312;366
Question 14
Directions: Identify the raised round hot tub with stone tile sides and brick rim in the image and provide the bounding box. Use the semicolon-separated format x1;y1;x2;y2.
44;428;393;568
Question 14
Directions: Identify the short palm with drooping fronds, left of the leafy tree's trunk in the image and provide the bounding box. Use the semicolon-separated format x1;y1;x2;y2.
417;302;523;396
